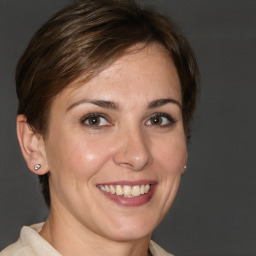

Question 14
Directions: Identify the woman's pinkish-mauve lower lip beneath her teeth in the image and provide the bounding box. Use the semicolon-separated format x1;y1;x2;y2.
98;185;156;207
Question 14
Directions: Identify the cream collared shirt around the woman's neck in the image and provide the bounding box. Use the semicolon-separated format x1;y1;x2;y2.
0;223;173;256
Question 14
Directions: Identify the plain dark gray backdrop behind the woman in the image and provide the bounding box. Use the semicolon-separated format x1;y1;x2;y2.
0;0;256;256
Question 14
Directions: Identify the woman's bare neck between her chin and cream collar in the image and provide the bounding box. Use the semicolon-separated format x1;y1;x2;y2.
40;210;150;256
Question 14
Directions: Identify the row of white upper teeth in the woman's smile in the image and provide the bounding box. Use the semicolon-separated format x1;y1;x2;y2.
99;184;151;197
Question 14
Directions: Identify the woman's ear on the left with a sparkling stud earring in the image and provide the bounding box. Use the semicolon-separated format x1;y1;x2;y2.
16;115;48;175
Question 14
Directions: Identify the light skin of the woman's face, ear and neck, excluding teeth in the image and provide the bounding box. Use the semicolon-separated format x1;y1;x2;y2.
17;44;187;256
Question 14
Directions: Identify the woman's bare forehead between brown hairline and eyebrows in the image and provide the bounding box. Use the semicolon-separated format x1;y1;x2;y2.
52;44;181;108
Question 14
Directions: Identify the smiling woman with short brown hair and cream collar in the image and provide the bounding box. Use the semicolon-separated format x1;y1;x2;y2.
1;0;198;256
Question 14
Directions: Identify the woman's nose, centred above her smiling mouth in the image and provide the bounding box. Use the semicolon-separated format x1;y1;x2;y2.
113;126;152;171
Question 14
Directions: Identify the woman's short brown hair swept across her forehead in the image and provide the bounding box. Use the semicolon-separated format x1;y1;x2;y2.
16;0;199;206
